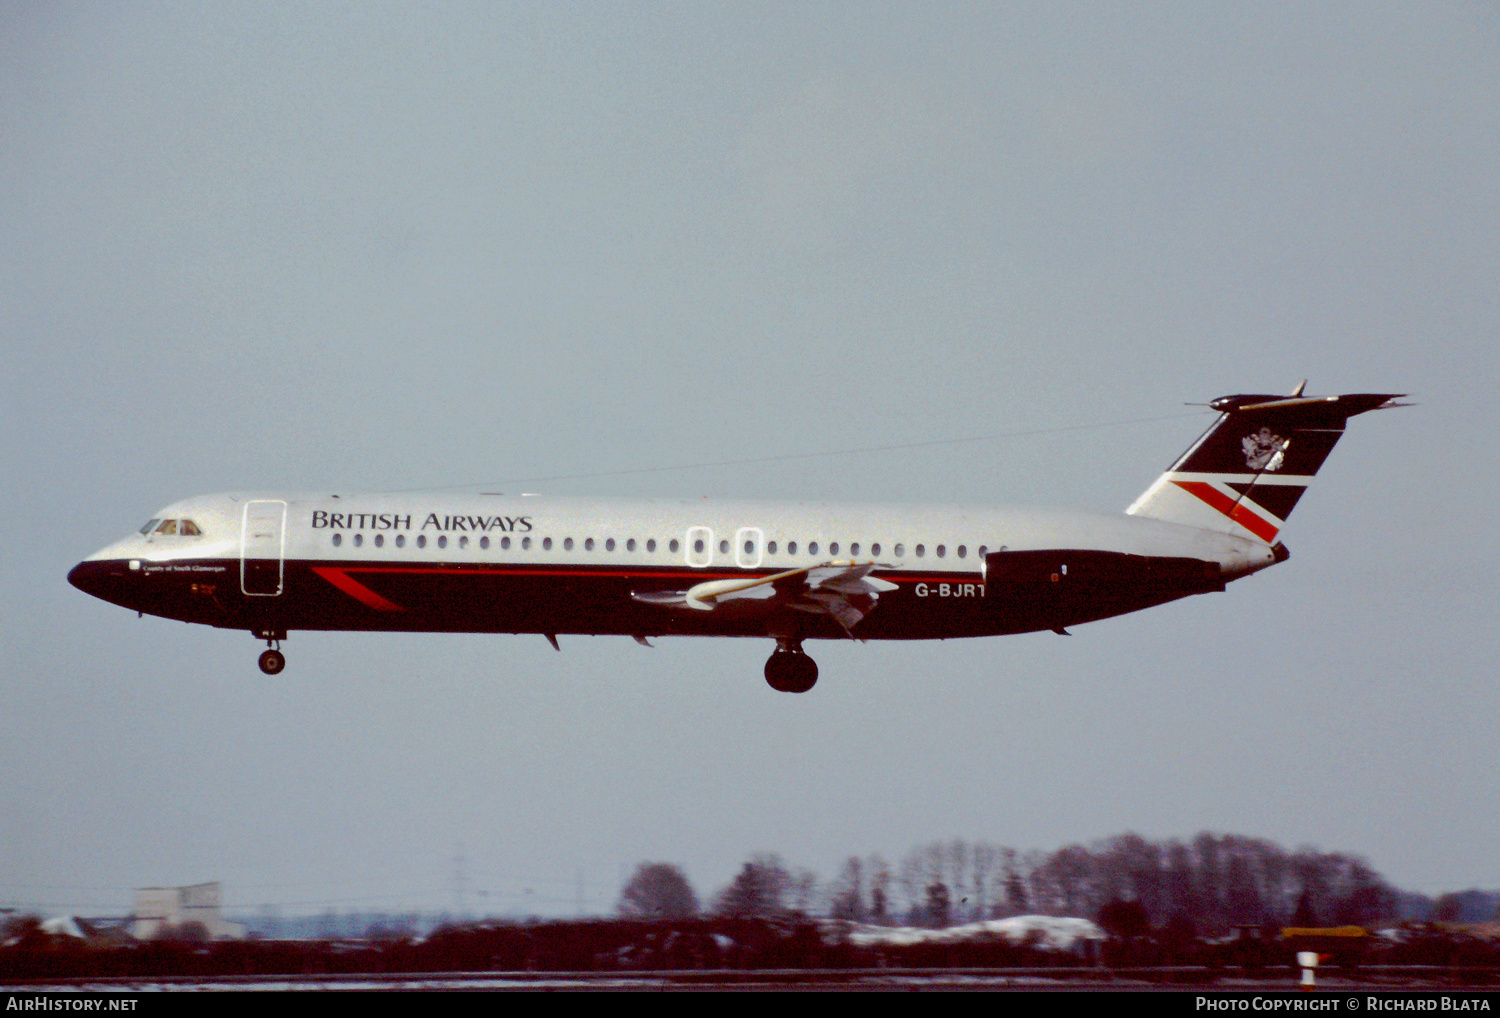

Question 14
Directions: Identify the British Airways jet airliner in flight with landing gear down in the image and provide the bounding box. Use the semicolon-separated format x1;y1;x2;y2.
68;382;1407;693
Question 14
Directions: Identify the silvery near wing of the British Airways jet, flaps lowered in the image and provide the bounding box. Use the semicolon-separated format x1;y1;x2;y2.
630;562;896;637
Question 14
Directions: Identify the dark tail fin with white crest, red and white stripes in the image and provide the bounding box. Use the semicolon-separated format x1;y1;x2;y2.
1125;385;1404;544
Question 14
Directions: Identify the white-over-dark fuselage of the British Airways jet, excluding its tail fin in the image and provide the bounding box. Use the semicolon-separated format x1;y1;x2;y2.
75;493;1274;639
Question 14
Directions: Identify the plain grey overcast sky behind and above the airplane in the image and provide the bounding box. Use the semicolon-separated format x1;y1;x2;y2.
0;0;1500;913
